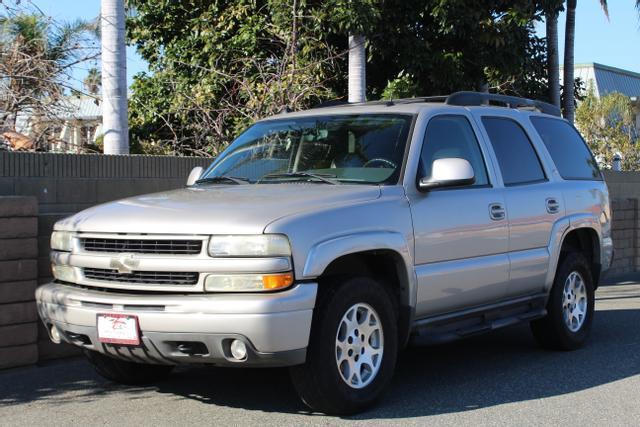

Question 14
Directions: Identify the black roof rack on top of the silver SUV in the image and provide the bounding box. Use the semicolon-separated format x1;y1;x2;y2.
312;91;562;117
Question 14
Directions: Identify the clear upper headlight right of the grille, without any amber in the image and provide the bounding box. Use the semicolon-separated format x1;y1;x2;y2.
209;234;291;257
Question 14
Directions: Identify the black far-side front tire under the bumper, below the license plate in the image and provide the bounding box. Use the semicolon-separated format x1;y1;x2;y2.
84;350;173;385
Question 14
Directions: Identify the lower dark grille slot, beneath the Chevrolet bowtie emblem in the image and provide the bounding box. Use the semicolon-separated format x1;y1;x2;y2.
83;268;198;285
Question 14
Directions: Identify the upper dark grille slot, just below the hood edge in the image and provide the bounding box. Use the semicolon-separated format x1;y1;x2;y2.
80;237;202;255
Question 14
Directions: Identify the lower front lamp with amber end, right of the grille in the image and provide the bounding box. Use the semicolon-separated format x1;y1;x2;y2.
204;273;293;292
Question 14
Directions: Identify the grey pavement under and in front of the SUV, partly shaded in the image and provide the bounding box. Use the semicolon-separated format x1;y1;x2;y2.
0;283;640;426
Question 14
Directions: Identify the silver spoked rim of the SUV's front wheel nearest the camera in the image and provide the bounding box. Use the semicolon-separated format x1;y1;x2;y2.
335;303;384;389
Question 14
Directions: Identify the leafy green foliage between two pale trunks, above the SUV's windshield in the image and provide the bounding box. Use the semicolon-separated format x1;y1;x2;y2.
129;0;366;155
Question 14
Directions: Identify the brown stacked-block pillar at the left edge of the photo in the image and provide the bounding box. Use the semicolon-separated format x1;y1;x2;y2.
0;197;38;369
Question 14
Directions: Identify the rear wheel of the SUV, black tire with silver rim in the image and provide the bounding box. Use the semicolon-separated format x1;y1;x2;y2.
531;252;595;351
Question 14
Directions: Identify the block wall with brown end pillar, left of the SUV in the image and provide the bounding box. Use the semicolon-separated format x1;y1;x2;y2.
0;151;211;368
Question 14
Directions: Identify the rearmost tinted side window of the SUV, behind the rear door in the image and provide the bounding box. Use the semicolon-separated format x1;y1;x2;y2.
531;117;602;181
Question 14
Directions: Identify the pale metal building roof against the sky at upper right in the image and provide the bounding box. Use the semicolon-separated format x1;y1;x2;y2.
575;62;640;97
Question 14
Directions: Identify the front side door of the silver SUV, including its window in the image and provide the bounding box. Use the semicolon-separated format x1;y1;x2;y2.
407;114;509;318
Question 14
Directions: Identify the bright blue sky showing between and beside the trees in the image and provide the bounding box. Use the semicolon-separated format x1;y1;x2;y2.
31;0;640;88
